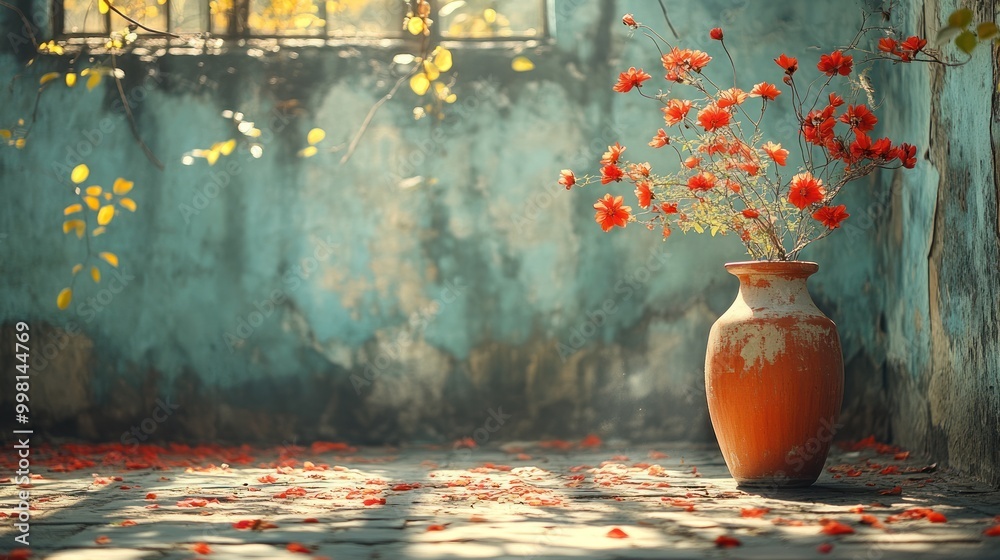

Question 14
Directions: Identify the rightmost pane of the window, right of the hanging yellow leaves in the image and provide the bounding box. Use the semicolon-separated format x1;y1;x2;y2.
438;0;544;39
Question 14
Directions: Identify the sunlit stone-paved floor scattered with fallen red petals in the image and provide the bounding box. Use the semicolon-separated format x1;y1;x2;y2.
0;437;1000;560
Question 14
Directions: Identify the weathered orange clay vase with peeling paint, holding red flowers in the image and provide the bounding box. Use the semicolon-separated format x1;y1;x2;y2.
705;261;844;487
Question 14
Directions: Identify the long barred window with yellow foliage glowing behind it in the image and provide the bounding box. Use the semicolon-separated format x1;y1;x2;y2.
56;0;547;40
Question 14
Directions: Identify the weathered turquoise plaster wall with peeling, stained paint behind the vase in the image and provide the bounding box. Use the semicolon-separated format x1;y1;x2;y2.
0;0;1000;482
